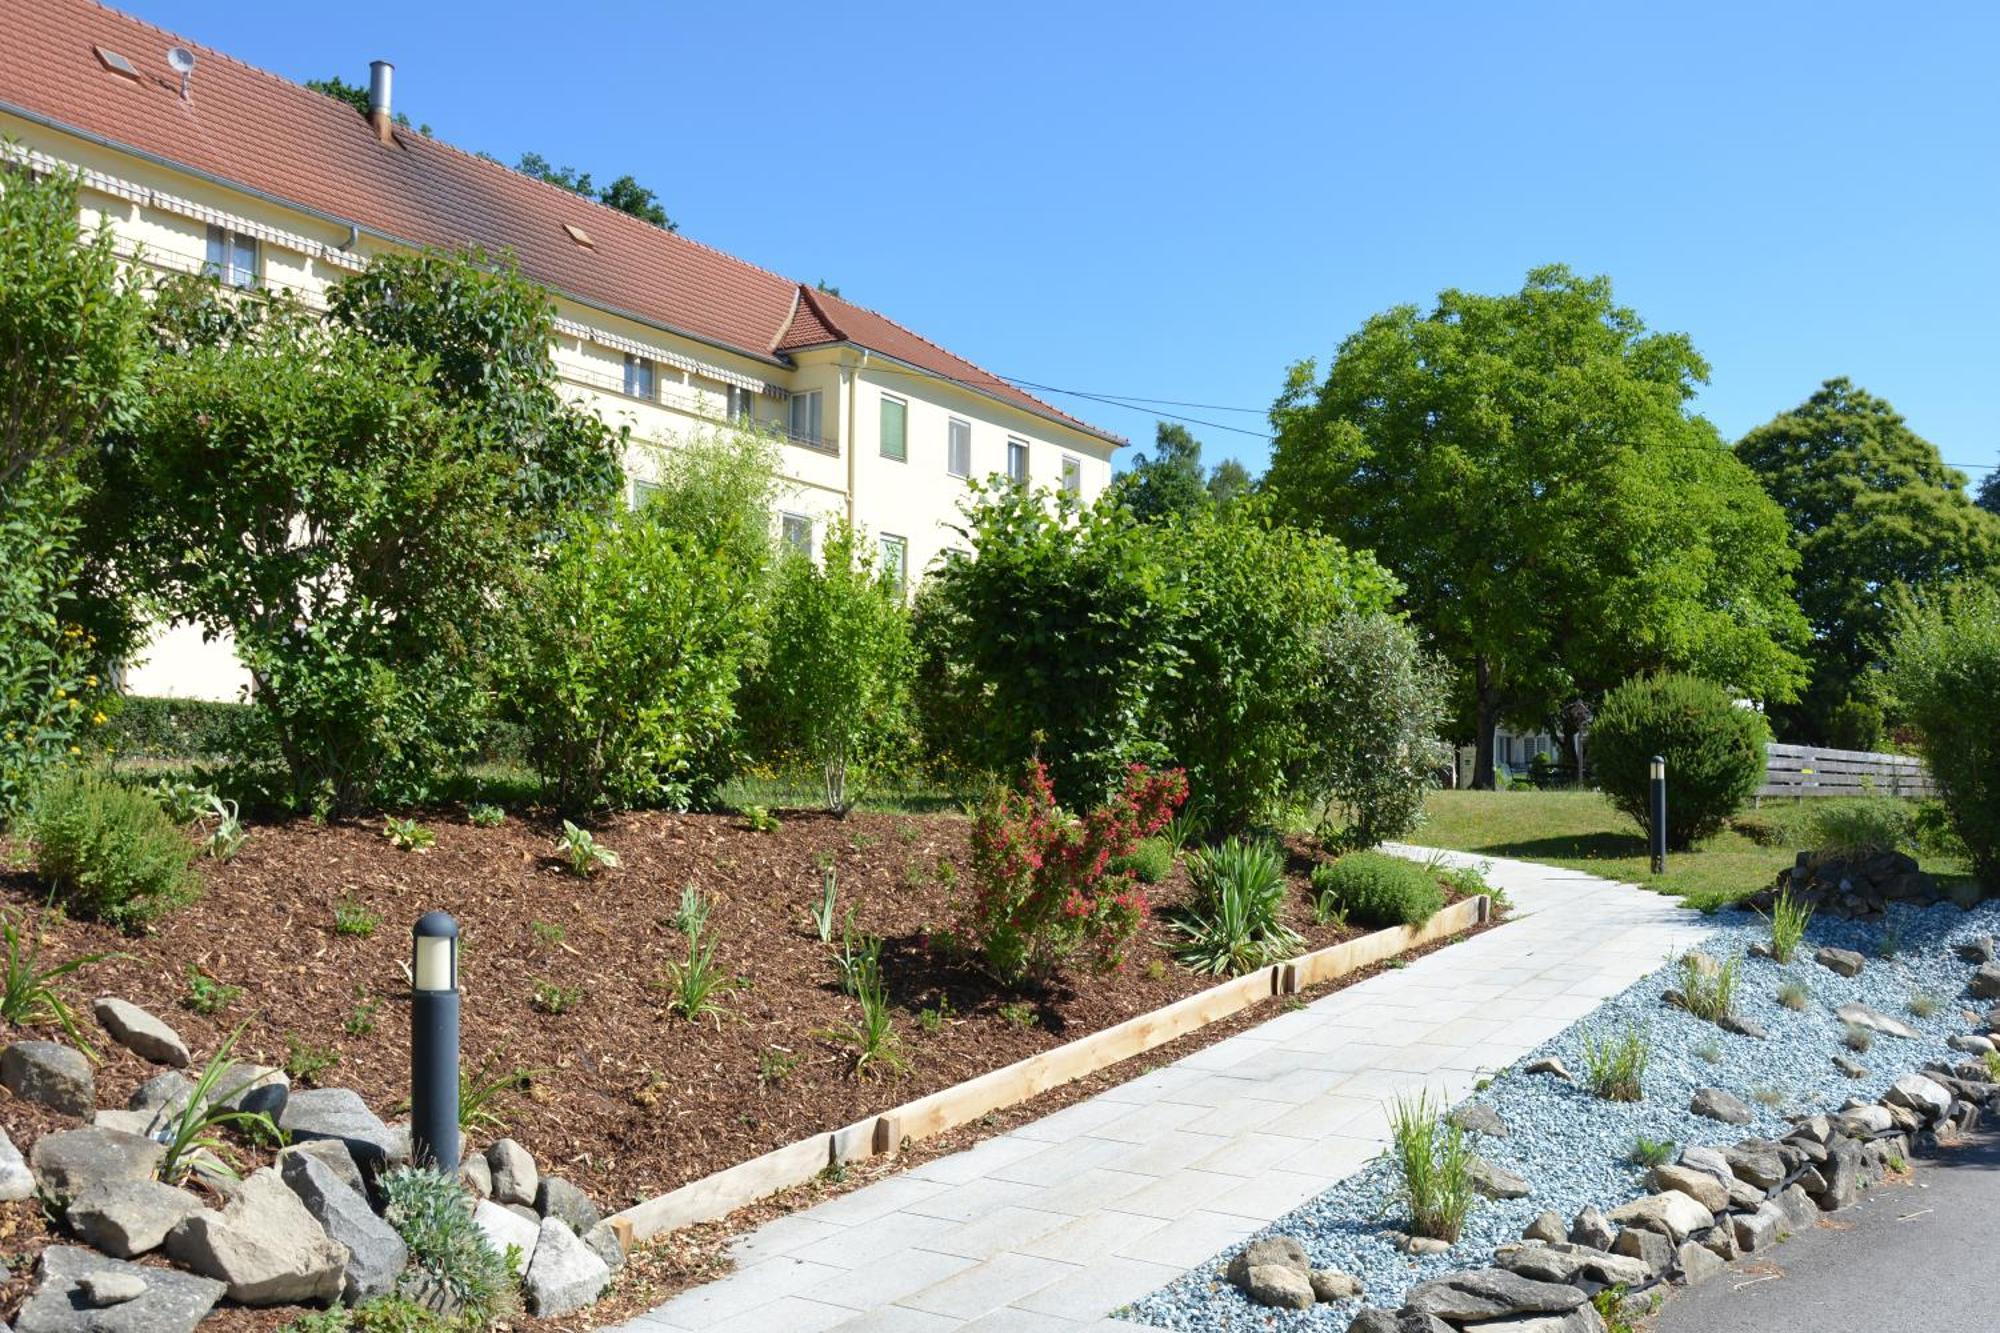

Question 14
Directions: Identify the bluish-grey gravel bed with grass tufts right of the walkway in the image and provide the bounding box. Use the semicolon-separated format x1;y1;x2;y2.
1120;905;2000;1333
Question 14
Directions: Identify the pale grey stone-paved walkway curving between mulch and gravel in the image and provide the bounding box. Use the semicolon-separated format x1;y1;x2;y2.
600;849;1704;1333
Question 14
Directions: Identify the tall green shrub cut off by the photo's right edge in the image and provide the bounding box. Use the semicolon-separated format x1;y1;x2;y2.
1888;586;2000;887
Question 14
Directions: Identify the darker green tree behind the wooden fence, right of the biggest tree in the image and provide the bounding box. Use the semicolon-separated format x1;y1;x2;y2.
1736;378;2000;741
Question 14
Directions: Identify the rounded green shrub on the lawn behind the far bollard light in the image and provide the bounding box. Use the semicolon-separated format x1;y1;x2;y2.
1590;675;1770;851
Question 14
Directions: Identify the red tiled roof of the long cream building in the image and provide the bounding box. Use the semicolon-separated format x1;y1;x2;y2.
0;0;1122;442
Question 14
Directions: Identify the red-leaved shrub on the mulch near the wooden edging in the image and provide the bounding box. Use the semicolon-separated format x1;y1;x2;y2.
964;761;1188;985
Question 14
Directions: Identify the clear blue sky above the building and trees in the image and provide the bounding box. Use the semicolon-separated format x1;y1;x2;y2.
129;0;2000;480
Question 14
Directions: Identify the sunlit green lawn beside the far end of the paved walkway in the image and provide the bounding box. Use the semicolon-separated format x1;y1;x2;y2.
1408;791;1966;911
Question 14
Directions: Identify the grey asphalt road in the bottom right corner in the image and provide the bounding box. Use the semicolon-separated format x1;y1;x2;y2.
1652;1131;2000;1333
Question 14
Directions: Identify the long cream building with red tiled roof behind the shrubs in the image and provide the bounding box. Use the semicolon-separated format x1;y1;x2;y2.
0;0;1124;699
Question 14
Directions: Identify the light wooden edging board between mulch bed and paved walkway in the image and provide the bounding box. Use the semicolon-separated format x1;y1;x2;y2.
610;895;1492;1245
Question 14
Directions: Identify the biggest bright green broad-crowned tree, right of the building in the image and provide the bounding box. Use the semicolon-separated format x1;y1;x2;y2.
1264;266;1804;787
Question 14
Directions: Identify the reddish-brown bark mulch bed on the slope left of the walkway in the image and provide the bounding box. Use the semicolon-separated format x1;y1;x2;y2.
0;811;1496;1329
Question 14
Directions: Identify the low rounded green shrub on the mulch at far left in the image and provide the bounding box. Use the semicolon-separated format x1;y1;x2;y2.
28;773;202;931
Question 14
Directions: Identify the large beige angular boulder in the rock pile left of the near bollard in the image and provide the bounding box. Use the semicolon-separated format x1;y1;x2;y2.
166;1167;348;1305
